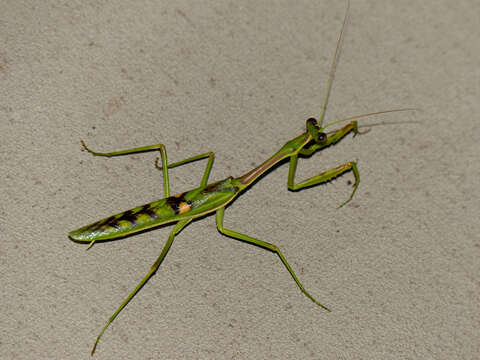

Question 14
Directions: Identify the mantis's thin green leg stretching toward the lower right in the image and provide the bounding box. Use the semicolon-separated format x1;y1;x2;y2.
216;208;330;311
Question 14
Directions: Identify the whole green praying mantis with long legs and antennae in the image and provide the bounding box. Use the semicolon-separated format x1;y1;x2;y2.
68;2;414;355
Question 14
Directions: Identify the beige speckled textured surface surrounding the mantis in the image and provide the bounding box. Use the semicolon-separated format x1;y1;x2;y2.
0;0;480;359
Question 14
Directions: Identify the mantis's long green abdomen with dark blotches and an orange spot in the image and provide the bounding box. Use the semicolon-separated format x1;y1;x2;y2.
68;177;238;242
